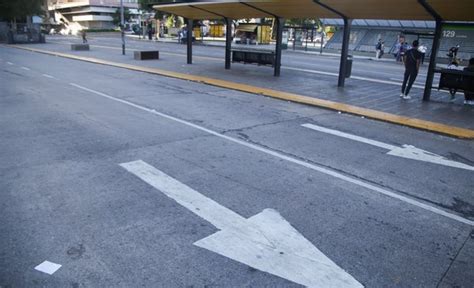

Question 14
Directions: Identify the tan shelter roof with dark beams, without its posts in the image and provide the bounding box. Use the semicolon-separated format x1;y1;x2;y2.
153;0;474;21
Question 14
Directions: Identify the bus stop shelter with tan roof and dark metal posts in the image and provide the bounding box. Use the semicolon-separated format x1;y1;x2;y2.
153;0;474;101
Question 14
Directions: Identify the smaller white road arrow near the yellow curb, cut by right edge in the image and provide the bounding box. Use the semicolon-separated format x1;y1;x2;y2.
301;124;474;171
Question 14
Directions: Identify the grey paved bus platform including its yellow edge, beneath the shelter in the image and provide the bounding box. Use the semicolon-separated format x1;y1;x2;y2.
7;41;474;139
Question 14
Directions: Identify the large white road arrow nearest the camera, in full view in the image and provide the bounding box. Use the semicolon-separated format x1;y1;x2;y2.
120;160;363;287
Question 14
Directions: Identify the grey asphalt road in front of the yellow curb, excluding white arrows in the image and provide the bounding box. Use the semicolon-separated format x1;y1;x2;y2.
0;47;474;288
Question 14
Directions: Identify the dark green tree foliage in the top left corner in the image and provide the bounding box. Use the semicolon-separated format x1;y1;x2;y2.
0;0;45;21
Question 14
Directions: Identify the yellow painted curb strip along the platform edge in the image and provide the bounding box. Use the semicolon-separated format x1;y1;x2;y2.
7;45;474;139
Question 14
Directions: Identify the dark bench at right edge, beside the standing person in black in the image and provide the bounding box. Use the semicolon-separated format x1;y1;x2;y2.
435;69;474;97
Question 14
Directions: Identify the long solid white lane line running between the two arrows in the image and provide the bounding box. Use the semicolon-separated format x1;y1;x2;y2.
69;83;474;226
